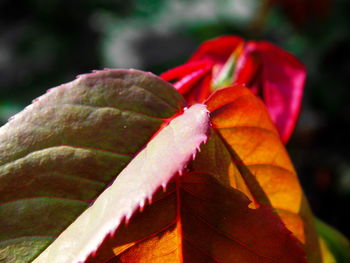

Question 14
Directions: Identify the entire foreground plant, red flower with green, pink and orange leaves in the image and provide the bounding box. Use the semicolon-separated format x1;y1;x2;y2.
0;37;349;263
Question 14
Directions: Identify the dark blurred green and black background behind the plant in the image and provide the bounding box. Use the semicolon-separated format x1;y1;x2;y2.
0;0;350;237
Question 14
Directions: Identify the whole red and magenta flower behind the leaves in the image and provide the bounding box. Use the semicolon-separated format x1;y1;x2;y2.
161;36;305;143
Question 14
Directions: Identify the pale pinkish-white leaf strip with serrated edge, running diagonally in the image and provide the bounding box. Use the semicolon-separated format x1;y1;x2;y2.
33;105;209;263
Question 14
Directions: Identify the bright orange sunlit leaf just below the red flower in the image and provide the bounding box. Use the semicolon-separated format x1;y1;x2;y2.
193;86;320;262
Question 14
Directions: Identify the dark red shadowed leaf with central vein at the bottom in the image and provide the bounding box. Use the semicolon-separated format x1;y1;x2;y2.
86;173;306;263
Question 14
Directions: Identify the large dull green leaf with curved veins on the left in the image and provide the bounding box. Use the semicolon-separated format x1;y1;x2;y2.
0;70;184;263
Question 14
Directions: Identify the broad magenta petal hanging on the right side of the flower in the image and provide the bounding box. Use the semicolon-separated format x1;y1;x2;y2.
252;42;306;143
